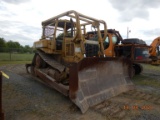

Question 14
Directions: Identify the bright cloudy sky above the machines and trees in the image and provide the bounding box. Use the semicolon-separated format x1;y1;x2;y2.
0;0;160;46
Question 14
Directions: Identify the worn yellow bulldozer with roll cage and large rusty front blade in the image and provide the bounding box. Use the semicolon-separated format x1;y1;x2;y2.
26;10;134;113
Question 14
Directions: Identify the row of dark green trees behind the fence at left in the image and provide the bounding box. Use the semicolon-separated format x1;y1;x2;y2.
0;37;33;53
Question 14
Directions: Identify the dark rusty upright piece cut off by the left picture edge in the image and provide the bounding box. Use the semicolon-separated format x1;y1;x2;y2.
0;72;4;120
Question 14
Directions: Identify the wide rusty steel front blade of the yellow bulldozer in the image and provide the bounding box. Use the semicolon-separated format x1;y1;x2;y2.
69;58;134;113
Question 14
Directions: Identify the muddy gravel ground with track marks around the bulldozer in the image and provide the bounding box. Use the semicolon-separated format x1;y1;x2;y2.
0;65;160;120
